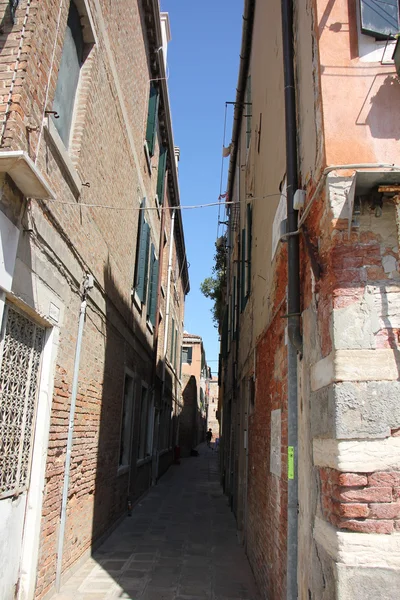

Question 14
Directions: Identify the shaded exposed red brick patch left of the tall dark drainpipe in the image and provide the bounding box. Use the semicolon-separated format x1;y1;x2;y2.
247;251;287;600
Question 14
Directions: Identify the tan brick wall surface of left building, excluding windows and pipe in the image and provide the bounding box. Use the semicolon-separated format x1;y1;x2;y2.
0;0;184;599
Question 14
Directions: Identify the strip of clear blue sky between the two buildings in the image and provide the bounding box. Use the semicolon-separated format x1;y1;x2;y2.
160;0;243;374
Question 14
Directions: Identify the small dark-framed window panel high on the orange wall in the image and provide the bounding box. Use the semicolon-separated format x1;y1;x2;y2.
360;0;399;39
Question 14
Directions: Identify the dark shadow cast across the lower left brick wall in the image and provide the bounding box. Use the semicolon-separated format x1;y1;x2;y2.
88;264;176;546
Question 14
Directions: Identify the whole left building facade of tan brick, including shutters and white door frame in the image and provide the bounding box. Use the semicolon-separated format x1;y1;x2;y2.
0;0;189;600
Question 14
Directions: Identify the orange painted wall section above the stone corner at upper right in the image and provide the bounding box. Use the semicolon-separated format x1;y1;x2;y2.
316;0;400;165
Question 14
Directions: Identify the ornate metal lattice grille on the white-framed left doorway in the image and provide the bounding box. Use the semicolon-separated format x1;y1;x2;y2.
0;306;45;498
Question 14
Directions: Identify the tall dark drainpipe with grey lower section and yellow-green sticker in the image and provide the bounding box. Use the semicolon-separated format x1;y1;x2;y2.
281;0;303;600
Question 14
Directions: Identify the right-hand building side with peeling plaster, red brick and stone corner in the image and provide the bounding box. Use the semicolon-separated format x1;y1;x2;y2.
220;0;400;600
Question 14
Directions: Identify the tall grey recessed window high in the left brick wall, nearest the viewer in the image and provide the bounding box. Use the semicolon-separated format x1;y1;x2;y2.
53;2;84;148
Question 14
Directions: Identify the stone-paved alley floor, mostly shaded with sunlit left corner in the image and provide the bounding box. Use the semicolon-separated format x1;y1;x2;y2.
53;446;259;600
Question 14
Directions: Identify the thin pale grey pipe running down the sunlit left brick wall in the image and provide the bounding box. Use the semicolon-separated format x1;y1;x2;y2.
56;275;93;592
